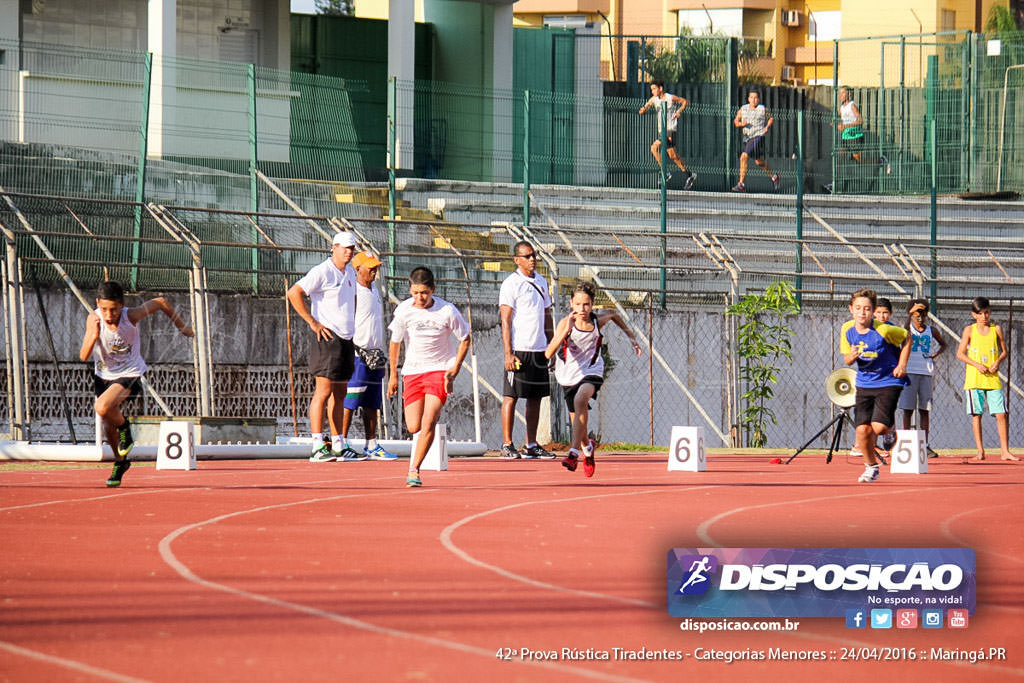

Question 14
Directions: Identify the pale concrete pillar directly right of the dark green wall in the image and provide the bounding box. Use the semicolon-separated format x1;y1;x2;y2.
387;0;416;169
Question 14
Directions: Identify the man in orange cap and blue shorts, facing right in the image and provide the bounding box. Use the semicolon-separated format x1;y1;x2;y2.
341;251;397;460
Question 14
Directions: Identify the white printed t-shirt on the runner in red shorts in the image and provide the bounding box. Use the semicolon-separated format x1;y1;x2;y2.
388;297;469;376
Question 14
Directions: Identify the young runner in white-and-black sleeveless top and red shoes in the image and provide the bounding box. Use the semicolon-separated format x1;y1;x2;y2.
544;283;641;477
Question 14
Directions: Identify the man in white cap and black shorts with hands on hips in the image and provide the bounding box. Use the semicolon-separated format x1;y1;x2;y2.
288;232;365;463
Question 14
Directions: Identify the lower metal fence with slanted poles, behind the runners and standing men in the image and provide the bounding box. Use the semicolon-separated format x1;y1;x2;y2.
0;187;1024;450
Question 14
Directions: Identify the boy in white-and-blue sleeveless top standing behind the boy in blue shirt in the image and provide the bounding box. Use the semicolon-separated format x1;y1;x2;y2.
896;299;946;458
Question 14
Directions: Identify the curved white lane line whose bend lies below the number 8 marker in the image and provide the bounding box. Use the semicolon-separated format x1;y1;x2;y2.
159;488;643;683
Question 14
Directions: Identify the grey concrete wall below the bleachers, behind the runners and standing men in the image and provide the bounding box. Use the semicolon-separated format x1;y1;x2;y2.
9;291;1024;451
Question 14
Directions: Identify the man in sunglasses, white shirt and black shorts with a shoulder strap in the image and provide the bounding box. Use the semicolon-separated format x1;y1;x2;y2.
498;242;554;460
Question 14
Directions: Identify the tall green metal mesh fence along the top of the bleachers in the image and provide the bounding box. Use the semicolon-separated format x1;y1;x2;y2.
6;32;1024;211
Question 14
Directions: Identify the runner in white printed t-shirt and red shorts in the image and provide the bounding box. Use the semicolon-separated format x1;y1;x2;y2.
387;267;469;486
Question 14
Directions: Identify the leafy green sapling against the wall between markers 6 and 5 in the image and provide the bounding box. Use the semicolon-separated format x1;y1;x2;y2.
726;281;800;449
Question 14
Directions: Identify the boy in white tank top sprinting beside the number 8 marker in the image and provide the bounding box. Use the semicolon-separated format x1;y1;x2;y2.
78;282;194;486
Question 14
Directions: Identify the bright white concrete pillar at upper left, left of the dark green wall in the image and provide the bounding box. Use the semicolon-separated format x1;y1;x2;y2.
146;0;178;157
